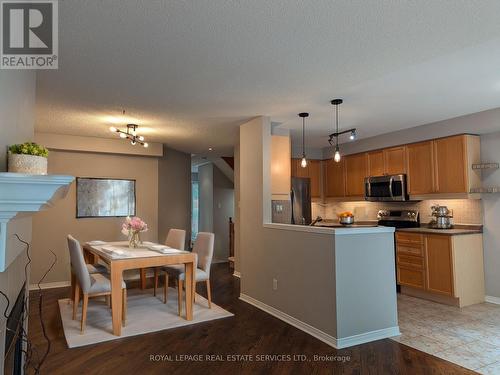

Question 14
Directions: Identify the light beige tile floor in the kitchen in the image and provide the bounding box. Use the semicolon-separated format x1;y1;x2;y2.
393;295;500;375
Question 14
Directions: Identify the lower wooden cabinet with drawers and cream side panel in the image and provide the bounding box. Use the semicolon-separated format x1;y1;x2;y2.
396;232;484;307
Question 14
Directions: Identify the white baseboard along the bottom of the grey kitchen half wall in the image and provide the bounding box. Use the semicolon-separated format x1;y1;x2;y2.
240;293;401;349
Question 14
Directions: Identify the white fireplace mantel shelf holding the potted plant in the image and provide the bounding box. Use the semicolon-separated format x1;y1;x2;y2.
0;173;74;272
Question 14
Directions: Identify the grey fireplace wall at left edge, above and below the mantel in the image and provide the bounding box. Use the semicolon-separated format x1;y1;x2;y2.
0;70;36;374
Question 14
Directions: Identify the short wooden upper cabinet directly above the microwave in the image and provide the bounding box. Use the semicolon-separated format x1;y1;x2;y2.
367;146;406;176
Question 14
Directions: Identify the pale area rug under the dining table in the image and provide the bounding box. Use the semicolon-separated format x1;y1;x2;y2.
59;288;234;348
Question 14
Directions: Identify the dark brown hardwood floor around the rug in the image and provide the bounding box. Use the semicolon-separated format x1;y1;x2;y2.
29;264;474;375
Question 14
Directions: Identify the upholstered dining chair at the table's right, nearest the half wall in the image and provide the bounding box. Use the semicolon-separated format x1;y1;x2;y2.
161;232;215;316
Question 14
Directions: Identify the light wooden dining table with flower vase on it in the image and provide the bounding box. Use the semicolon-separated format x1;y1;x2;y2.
83;241;196;336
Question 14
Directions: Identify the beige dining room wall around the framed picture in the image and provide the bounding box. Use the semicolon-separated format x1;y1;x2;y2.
31;151;158;283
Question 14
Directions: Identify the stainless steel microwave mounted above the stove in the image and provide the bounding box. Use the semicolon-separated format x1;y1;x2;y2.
365;174;408;201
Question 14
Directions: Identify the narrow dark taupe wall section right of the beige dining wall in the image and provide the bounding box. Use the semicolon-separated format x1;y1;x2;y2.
158;146;191;246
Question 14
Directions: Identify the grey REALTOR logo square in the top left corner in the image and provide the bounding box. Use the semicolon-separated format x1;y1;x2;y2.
0;0;59;69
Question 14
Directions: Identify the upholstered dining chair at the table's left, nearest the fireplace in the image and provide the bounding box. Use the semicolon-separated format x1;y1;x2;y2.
68;235;127;333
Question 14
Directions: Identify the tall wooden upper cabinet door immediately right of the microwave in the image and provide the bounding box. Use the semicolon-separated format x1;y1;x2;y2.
406;141;434;195
